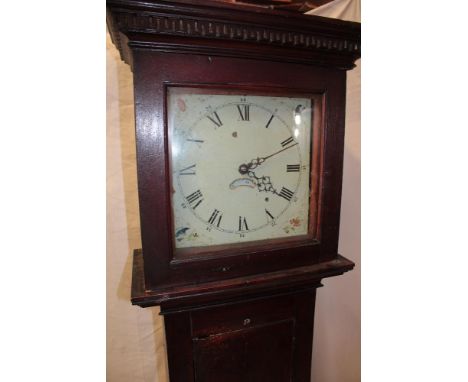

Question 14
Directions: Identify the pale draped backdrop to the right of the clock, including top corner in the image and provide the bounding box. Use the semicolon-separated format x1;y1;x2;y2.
309;0;361;382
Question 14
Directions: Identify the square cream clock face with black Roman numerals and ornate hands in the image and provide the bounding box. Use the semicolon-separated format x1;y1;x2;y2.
168;88;312;249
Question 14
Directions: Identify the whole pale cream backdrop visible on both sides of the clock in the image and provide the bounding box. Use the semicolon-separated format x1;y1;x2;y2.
107;0;361;382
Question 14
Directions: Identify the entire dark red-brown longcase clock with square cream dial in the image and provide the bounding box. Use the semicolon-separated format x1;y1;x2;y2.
107;0;360;382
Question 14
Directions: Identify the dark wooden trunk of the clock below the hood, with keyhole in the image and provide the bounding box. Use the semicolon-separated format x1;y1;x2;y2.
161;288;315;382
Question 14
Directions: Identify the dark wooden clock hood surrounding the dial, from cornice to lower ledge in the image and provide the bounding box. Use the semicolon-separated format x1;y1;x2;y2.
107;0;360;306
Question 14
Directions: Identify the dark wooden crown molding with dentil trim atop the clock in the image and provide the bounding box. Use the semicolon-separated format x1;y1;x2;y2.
107;0;361;70
